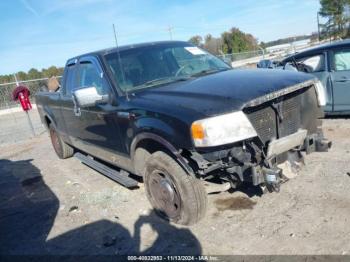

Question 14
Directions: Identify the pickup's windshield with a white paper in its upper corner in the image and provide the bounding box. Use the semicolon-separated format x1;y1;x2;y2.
106;43;230;91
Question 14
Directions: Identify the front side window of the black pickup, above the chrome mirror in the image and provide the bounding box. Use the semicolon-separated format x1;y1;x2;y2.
78;61;109;95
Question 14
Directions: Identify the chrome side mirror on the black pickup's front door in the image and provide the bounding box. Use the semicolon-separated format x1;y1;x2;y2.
73;87;109;108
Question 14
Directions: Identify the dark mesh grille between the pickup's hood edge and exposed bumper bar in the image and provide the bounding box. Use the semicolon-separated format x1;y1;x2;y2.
246;89;304;144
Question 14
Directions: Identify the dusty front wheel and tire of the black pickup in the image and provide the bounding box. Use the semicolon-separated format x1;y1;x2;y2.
144;151;207;225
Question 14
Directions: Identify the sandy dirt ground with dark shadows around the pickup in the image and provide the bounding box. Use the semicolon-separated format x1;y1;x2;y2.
0;119;350;255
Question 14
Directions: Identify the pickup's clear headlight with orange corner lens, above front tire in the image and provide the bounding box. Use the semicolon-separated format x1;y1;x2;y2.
191;111;257;147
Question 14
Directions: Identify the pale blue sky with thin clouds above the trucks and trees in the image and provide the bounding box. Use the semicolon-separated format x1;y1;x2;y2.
0;0;320;75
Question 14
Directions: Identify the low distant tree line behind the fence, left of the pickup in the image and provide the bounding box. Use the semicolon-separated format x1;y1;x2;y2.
0;66;64;83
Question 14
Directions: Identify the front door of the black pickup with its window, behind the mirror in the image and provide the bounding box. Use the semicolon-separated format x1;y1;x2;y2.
69;56;122;164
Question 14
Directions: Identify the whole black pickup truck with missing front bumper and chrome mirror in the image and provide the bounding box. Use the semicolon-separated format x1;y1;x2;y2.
36;41;331;225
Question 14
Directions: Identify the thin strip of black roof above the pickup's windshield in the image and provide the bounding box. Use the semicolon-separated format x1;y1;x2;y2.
67;41;192;64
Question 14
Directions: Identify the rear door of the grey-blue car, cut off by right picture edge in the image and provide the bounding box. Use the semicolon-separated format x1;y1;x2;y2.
331;48;350;112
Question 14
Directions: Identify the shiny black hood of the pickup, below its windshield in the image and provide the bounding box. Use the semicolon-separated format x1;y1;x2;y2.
135;69;314;116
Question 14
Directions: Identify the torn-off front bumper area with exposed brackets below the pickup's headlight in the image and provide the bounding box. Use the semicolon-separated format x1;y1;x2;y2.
186;129;332;192
